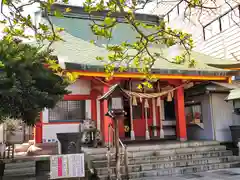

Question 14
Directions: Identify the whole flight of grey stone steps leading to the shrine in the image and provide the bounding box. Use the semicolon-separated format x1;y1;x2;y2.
86;141;240;180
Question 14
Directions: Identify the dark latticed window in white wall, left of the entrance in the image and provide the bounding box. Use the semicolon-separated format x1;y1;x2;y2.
48;100;86;122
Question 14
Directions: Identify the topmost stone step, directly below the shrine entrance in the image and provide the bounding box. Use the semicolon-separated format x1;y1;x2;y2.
85;141;220;155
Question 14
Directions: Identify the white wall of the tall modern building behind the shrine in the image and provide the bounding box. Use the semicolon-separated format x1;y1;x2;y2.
165;2;240;60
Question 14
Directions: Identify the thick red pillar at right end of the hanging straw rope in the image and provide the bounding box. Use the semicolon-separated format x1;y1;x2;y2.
175;87;187;141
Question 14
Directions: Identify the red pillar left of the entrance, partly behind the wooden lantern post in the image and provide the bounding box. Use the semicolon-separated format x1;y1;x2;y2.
100;85;113;145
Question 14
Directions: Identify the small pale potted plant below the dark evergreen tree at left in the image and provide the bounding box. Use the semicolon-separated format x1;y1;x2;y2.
4;118;24;144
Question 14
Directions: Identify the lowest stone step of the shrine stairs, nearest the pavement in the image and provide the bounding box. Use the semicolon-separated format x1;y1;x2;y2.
99;161;239;180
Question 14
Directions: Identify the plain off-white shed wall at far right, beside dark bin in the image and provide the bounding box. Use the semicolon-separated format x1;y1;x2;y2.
211;93;233;142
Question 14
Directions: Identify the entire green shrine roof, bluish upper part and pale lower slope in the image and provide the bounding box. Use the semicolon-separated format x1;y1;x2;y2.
33;17;238;76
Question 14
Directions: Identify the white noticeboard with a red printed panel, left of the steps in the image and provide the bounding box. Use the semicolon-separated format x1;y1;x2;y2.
50;153;85;179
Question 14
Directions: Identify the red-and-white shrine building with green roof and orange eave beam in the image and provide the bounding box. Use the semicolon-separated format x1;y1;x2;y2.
35;5;236;143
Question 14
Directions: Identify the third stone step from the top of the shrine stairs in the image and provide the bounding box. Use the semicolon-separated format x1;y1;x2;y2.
92;150;232;168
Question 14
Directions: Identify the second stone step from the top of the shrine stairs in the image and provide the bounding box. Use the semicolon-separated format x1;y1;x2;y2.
90;145;226;160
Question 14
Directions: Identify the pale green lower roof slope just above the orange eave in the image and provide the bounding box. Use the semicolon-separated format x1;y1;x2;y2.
47;28;233;76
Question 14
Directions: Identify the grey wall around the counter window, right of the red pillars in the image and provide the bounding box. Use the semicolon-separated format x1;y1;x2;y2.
187;95;214;140
